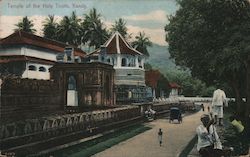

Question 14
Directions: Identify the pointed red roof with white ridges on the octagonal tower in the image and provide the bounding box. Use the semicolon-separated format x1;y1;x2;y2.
88;32;143;55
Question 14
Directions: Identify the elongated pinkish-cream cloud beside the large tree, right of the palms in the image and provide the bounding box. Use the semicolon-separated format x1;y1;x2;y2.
122;10;167;22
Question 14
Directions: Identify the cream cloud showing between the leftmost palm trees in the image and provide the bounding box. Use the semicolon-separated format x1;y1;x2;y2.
0;15;62;38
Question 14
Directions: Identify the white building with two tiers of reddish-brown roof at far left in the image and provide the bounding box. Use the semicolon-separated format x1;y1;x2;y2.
0;31;85;80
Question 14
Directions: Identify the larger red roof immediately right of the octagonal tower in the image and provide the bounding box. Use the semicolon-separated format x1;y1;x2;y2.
145;70;161;88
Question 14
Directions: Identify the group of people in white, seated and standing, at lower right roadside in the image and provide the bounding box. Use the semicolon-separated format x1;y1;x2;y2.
196;89;250;157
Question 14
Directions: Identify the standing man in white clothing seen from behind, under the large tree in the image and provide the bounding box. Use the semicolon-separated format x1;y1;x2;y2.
211;89;228;125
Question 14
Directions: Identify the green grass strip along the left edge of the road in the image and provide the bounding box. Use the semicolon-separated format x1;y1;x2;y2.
51;124;151;157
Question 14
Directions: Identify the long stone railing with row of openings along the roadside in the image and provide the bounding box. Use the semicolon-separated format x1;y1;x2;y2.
0;106;140;141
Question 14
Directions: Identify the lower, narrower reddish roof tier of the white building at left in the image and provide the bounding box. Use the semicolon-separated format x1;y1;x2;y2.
0;55;55;65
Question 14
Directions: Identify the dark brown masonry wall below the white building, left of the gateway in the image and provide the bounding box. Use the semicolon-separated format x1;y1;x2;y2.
0;78;63;122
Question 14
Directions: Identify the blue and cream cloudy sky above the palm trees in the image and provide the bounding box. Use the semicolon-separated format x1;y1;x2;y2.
0;0;178;45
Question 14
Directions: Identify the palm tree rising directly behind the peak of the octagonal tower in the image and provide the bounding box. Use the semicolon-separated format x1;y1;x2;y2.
111;18;130;38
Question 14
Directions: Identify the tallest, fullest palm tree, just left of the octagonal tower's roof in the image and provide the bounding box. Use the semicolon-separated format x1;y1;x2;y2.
81;8;110;48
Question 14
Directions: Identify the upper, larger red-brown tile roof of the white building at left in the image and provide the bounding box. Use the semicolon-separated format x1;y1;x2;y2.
0;31;86;57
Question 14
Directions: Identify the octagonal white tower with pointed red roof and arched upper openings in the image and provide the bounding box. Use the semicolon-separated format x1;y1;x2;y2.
86;32;146;103
